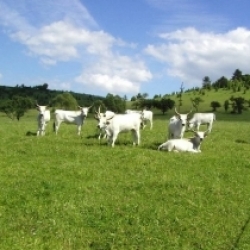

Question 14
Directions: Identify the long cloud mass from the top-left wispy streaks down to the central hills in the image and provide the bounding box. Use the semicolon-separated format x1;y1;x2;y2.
0;0;152;94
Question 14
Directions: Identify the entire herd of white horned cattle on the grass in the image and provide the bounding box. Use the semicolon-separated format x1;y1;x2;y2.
36;104;215;153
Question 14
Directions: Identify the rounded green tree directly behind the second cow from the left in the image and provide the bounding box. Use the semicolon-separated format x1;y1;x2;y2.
51;92;78;110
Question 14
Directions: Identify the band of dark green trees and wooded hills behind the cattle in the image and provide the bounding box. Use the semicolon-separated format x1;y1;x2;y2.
0;69;250;120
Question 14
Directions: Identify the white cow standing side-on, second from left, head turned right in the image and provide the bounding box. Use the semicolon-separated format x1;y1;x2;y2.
54;106;92;135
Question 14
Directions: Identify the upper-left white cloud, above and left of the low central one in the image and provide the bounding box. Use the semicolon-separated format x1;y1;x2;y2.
12;21;116;62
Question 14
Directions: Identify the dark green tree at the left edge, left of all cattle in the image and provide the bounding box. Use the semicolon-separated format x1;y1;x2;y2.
0;96;33;121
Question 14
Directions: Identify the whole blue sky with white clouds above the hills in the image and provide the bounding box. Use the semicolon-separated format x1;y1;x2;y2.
0;0;250;98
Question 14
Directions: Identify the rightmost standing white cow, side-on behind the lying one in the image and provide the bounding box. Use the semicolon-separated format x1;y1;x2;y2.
188;113;216;133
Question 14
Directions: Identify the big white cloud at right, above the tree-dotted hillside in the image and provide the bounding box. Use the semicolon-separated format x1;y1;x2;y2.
145;28;250;86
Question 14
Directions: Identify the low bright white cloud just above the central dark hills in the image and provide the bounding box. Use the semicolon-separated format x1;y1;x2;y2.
76;55;152;94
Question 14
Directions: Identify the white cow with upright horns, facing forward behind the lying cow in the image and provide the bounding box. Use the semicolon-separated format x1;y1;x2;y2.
168;108;192;139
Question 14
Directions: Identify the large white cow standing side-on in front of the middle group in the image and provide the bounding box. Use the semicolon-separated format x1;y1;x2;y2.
95;113;142;147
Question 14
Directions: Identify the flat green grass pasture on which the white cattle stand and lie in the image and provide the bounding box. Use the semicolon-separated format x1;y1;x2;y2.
0;111;250;250
